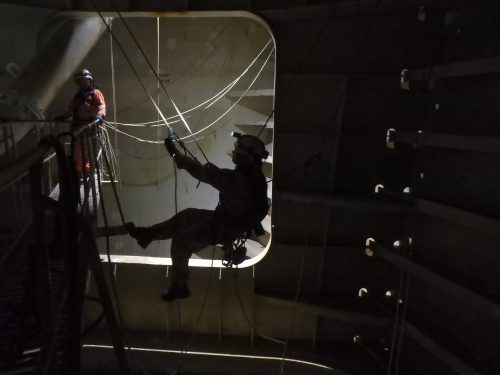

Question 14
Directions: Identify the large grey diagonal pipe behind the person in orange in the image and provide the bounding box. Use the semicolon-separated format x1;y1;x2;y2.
0;15;106;154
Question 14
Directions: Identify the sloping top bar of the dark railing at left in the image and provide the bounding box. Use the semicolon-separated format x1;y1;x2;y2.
0;120;101;191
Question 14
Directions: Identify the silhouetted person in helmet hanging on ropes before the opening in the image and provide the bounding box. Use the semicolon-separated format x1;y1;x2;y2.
126;133;268;302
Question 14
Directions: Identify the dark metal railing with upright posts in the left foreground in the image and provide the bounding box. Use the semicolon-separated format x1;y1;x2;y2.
0;120;121;374
